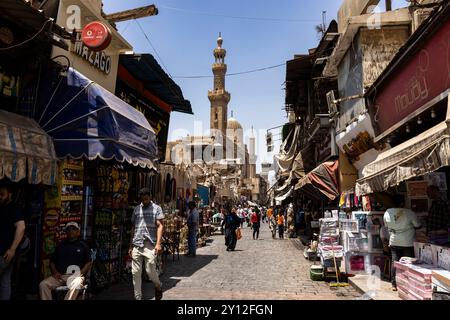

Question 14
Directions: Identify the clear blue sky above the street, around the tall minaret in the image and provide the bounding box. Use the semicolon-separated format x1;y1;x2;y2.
103;0;404;171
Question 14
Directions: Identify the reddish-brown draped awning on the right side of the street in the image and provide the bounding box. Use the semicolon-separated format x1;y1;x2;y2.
295;160;339;200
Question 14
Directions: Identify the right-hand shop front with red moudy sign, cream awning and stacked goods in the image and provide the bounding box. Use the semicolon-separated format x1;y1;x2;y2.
352;3;450;300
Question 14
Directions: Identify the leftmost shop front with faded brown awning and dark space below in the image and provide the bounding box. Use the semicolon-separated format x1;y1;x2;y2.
0;110;59;299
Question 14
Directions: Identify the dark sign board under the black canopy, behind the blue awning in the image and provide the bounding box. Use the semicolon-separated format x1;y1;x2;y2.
116;80;170;160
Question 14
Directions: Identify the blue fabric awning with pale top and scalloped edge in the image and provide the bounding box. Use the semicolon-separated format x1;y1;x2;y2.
36;68;157;169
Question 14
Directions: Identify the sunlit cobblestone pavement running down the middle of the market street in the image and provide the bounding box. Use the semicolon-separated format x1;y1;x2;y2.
97;224;360;300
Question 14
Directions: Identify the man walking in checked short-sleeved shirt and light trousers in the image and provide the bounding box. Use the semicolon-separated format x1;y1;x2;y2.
129;188;164;300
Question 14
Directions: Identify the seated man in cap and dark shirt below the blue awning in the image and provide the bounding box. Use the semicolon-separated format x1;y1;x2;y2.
39;222;92;300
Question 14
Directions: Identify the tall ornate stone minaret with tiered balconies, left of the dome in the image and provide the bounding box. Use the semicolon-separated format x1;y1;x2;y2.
208;33;231;144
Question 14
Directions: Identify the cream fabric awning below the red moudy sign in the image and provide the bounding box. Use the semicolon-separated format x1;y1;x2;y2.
356;122;450;195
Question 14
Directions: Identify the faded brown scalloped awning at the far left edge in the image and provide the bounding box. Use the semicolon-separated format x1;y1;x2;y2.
0;110;58;185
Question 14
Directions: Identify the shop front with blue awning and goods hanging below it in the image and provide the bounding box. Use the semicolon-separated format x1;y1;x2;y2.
36;68;157;289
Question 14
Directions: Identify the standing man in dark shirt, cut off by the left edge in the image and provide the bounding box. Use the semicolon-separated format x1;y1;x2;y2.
0;185;25;300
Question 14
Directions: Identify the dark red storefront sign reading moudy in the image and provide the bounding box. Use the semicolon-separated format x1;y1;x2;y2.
374;20;450;135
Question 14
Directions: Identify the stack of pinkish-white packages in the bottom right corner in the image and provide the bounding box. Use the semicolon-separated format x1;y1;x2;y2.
395;261;442;300
